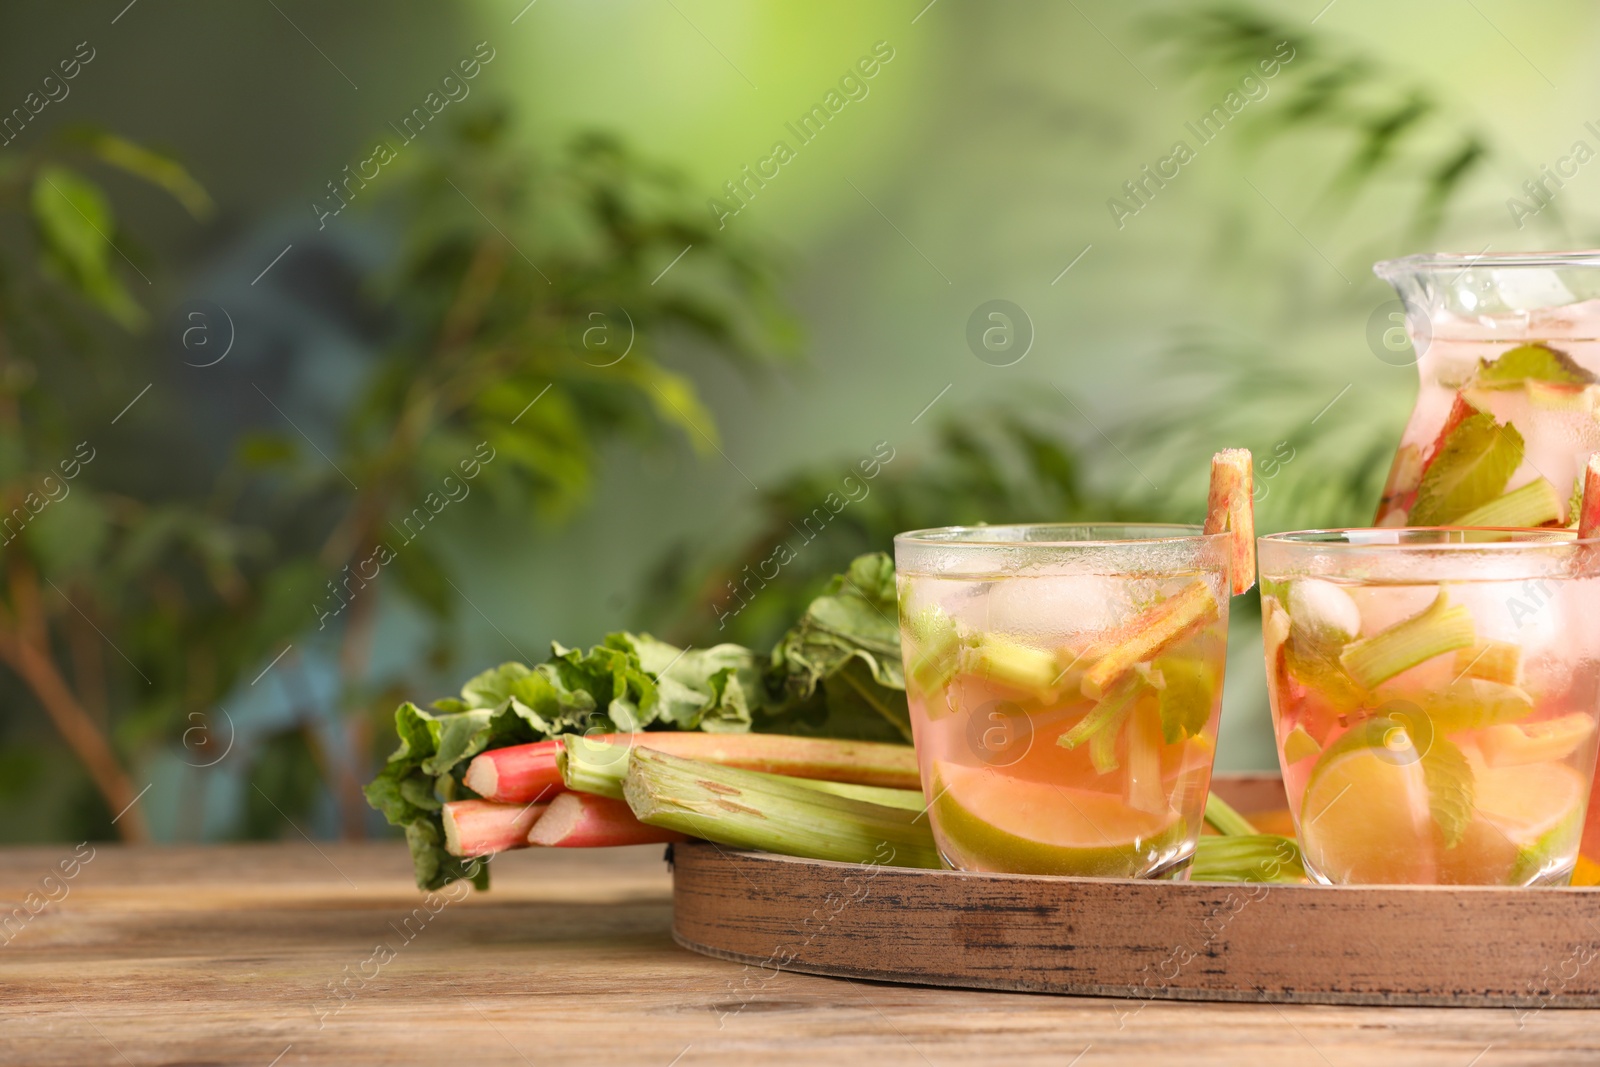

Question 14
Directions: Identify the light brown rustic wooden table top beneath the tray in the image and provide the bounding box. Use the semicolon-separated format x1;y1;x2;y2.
0;843;1600;1067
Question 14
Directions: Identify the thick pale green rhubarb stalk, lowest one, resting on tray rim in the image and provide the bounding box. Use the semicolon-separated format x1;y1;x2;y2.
622;749;942;869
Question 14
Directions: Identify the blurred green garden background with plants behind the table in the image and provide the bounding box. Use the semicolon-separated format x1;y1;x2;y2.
0;0;1600;841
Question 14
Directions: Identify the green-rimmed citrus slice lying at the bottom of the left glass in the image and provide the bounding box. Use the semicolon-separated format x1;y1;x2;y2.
933;760;1186;878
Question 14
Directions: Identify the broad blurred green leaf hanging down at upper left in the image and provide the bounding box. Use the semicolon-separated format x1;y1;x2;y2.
30;163;146;330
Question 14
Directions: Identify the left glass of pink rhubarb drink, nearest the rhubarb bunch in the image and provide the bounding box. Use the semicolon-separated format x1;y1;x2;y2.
894;521;1228;878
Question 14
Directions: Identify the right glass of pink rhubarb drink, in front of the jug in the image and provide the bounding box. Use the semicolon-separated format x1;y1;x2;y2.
1259;528;1600;886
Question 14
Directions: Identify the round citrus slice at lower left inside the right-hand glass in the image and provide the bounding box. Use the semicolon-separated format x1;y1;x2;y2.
1299;718;1434;885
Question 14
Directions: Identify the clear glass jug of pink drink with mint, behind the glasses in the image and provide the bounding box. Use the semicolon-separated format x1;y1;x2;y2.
1373;251;1600;526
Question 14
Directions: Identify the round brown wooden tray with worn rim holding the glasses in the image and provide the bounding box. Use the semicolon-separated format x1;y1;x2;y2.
672;776;1600;1013
